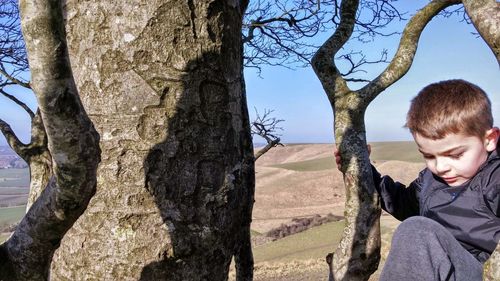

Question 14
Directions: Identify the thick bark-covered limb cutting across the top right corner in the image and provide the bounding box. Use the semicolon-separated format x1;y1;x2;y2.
462;0;500;66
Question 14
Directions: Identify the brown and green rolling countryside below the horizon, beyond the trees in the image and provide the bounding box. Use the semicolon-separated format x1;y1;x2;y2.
0;142;424;281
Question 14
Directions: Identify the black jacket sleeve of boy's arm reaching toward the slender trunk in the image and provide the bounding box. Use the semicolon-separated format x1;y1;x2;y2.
372;166;423;221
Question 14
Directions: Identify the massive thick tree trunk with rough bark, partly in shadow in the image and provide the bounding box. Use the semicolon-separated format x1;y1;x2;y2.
51;0;254;280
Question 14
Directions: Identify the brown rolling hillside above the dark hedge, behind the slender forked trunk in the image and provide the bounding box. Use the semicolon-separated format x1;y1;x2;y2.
252;142;424;233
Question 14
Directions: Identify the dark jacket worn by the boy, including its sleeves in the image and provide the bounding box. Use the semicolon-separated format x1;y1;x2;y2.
373;143;500;262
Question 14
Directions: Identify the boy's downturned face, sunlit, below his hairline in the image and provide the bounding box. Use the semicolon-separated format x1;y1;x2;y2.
413;128;498;186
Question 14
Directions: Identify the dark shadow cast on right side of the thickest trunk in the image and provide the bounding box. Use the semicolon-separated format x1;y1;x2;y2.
140;53;254;280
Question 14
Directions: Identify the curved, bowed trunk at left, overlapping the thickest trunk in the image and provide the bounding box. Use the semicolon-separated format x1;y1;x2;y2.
0;0;99;280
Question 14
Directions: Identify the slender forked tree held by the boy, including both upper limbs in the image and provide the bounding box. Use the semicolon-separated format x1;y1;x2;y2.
312;0;460;280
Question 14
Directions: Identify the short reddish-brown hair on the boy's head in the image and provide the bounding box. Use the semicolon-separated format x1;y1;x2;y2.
405;80;493;140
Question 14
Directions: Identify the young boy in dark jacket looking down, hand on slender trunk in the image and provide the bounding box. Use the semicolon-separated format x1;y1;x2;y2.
335;80;500;281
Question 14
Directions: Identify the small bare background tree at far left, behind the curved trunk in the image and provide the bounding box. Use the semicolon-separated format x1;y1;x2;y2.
0;0;52;210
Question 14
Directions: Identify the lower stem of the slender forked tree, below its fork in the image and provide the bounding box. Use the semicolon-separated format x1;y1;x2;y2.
333;92;381;281
